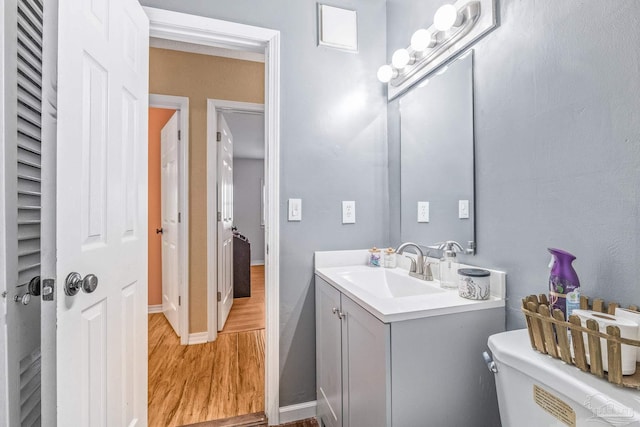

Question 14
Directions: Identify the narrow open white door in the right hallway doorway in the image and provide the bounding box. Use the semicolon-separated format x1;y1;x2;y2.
217;114;233;331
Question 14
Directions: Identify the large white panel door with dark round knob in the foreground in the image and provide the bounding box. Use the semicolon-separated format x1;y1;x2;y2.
43;0;149;427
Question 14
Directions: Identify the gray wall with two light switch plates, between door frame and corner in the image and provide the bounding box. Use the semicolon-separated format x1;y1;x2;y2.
141;0;389;406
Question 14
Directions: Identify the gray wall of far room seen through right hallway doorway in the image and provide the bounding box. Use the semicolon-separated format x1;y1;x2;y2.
233;157;264;263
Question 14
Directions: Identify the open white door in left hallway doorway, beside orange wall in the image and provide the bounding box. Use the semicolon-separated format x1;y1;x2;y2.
160;111;180;336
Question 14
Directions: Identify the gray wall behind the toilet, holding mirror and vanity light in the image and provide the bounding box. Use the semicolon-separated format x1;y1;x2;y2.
387;0;640;329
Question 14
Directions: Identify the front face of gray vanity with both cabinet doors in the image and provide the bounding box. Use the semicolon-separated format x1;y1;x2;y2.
316;276;391;427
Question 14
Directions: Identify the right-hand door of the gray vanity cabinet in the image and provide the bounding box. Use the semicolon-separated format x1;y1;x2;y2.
342;295;391;427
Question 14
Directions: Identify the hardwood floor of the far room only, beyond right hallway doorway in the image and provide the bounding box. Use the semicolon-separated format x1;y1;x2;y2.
220;265;265;334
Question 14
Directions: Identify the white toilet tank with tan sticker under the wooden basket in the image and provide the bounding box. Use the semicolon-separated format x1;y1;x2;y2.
488;329;640;427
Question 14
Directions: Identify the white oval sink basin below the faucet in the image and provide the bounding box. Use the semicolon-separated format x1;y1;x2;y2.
336;266;446;298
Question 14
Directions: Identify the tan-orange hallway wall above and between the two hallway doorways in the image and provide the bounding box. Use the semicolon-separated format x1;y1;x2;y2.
149;48;264;333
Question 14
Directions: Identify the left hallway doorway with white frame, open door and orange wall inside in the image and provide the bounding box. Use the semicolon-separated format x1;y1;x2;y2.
148;94;189;345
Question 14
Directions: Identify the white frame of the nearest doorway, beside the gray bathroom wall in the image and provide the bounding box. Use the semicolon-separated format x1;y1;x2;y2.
148;7;280;425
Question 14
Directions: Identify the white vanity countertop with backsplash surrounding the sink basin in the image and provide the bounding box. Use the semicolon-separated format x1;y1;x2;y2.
315;249;506;323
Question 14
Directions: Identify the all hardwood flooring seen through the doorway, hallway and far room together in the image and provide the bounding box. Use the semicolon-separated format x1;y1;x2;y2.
148;266;265;427
